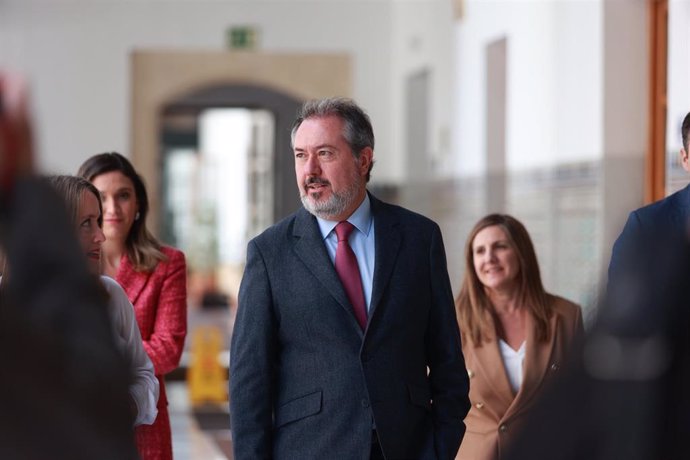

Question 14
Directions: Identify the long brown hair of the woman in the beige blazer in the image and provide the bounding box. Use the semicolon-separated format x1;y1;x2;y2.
455;214;551;346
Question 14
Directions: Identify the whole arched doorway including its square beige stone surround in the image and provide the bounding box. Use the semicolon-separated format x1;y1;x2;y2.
130;51;351;308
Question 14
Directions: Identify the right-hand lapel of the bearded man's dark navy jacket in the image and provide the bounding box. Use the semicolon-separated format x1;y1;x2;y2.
369;194;402;321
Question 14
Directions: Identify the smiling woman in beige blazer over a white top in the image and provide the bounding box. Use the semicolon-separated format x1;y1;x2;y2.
455;214;583;460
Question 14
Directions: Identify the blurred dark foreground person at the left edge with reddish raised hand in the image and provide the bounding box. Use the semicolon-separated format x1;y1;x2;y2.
0;75;137;460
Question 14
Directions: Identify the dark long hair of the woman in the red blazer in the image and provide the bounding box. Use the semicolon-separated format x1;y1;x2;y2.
77;152;167;271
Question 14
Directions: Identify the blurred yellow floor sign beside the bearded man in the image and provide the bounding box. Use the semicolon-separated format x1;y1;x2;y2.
187;326;228;405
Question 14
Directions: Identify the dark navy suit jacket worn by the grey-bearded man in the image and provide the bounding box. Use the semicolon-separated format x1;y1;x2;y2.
230;196;469;460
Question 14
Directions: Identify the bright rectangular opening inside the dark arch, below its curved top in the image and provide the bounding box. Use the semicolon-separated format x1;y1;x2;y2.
160;105;275;306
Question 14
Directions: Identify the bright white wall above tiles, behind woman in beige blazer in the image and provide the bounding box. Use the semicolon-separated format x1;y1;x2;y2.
453;0;603;176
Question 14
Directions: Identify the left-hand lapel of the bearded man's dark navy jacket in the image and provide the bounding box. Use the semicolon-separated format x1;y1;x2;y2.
293;209;363;334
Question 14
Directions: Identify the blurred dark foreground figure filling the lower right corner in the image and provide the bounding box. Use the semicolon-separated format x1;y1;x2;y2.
500;227;690;460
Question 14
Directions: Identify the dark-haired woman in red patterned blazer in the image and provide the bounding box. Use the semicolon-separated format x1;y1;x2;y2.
78;153;187;460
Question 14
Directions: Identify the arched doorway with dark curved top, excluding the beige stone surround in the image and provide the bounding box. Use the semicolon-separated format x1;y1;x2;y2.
159;85;300;310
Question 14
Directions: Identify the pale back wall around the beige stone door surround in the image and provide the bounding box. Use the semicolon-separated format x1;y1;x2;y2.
0;0;406;182
